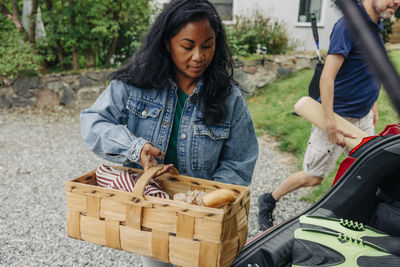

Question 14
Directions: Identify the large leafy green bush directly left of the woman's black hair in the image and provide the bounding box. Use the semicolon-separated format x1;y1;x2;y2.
39;0;155;70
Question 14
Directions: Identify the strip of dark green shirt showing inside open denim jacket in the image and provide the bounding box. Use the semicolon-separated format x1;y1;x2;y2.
164;88;189;168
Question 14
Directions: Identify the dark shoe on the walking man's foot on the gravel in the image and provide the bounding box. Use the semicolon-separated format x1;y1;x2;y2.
258;193;276;231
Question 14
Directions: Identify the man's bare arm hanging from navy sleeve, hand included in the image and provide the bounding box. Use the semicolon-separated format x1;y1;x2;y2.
319;54;354;146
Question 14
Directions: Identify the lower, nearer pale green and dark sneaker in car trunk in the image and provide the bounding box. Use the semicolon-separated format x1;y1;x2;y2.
292;228;400;267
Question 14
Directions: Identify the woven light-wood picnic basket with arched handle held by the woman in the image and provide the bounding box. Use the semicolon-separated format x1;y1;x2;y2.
65;165;250;267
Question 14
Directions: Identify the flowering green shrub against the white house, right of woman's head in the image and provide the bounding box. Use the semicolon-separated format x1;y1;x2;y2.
227;12;291;56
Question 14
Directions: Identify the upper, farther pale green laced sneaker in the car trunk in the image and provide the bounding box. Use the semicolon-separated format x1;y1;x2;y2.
299;215;400;256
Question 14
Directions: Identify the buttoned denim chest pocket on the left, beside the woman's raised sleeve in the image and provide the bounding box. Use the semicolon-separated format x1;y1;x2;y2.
126;98;162;141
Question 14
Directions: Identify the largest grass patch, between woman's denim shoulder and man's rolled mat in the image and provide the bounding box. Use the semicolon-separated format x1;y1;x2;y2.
247;70;313;168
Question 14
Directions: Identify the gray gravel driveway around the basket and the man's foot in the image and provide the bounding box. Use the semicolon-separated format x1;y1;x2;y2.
0;108;309;266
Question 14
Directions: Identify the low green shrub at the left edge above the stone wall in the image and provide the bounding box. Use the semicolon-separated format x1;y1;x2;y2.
0;15;41;78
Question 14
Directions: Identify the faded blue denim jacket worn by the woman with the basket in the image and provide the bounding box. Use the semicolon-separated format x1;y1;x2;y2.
81;80;258;185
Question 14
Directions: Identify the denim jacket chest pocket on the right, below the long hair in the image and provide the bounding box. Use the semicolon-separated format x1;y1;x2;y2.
191;122;230;170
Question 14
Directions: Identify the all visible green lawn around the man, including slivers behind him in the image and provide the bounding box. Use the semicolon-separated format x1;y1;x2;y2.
247;50;400;202
